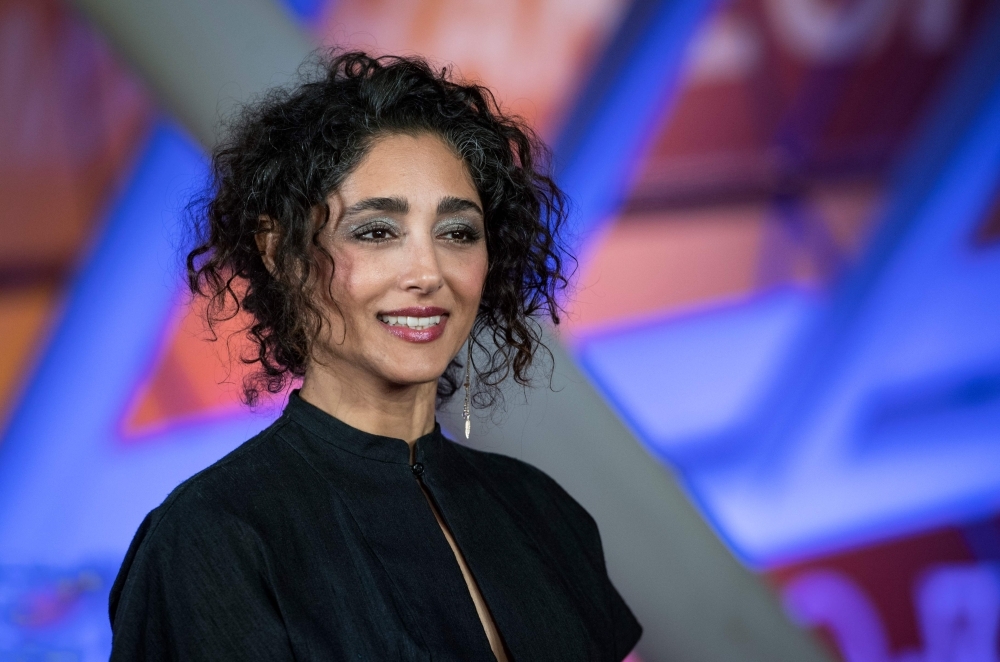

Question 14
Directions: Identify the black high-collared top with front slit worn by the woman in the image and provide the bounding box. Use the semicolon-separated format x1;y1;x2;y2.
110;393;642;662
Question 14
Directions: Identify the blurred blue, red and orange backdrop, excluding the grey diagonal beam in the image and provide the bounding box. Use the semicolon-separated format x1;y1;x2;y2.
0;0;1000;662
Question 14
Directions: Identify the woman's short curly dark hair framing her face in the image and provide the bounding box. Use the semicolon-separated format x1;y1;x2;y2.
187;51;572;407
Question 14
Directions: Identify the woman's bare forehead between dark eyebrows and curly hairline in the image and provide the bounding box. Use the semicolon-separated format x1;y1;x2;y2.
339;133;480;205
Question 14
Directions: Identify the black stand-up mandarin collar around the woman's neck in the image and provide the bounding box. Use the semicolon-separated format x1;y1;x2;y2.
282;389;443;465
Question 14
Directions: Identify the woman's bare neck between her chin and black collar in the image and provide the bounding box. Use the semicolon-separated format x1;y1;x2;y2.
299;362;437;447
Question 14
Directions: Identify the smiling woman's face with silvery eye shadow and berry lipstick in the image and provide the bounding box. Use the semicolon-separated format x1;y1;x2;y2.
308;134;487;386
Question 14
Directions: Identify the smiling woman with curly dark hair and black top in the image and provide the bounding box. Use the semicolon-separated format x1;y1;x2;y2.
110;53;641;662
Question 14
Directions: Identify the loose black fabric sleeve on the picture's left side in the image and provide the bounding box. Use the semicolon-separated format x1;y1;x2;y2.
109;492;293;662
